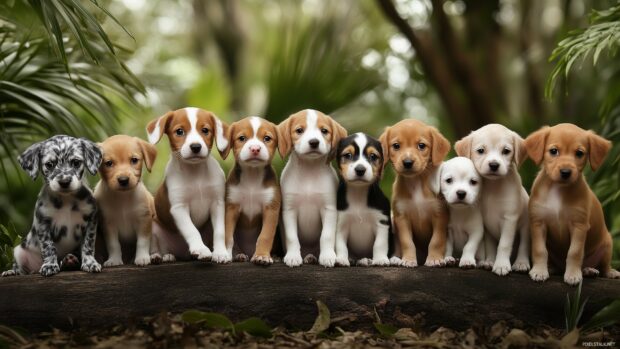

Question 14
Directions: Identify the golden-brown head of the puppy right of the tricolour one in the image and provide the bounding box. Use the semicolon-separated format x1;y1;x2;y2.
379;119;450;177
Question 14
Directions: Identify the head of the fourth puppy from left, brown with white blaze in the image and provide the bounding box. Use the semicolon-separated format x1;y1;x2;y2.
222;116;278;166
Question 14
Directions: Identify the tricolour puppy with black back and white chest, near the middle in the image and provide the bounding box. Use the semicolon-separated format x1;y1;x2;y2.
336;133;393;266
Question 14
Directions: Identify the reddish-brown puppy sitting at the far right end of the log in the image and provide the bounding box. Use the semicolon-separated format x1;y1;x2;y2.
525;124;620;285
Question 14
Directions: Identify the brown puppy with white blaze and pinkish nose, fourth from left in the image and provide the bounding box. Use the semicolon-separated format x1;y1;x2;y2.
223;116;281;264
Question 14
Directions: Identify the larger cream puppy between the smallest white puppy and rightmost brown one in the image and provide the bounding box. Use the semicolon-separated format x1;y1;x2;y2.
455;124;530;275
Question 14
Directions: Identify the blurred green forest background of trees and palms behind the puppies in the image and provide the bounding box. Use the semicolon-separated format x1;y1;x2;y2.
0;0;620;266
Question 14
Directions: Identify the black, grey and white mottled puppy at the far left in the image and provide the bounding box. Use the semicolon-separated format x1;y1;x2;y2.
2;135;101;276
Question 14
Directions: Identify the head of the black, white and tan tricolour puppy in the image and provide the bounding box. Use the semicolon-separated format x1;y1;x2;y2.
336;132;383;185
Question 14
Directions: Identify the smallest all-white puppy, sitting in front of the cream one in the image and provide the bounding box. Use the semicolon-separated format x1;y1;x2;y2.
437;156;484;268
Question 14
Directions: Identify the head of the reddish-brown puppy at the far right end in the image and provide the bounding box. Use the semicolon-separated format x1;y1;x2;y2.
525;124;611;184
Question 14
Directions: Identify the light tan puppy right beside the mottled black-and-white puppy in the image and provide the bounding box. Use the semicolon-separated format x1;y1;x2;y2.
95;135;157;267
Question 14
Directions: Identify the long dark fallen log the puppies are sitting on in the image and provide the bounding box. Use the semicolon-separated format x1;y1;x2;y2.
0;262;620;331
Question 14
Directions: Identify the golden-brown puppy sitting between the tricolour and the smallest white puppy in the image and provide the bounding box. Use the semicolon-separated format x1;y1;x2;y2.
379;119;450;267
